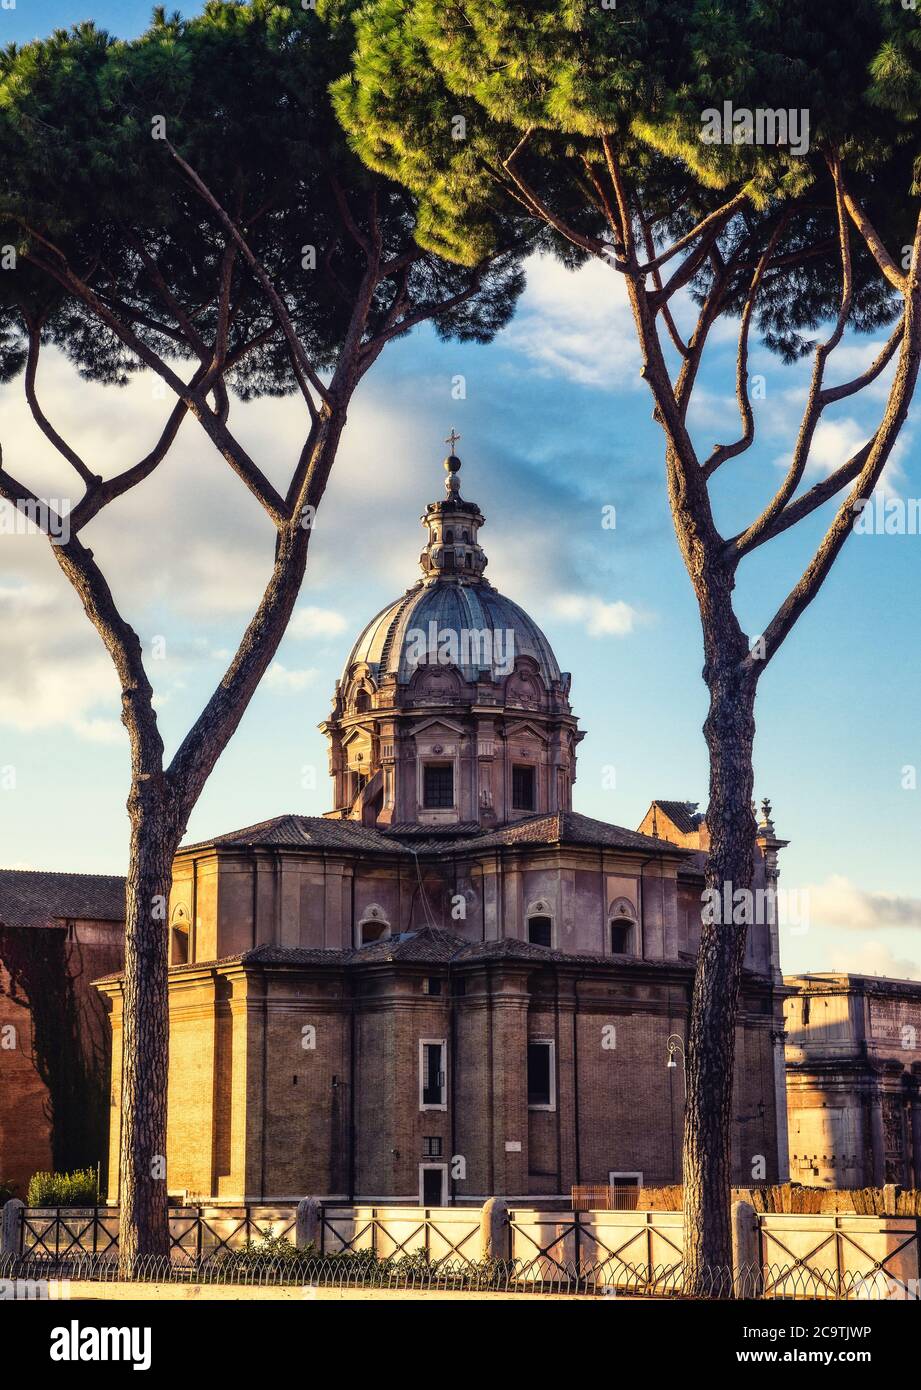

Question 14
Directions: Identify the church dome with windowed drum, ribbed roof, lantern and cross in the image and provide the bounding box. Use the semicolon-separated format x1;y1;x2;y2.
327;444;582;834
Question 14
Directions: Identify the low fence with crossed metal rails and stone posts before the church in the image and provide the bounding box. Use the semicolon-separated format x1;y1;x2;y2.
0;1200;921;1300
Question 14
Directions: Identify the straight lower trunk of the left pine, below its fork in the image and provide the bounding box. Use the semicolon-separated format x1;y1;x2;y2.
118;777;179;1273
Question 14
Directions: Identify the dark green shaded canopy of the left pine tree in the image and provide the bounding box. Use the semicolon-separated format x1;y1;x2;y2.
0;0;522;398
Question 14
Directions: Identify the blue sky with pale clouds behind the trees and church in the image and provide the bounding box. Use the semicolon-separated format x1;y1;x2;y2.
0;0;921;974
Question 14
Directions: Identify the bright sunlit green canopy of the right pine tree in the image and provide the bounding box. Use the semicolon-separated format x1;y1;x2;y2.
332;0;921;357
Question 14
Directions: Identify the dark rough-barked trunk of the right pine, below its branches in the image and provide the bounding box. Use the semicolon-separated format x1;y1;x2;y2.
683;664;756;1297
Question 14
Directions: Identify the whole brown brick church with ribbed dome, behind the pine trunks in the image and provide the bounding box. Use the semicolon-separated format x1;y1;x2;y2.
97;455;789;1205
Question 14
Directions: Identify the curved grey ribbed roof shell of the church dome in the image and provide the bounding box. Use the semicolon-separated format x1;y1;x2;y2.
343;578;560;685
